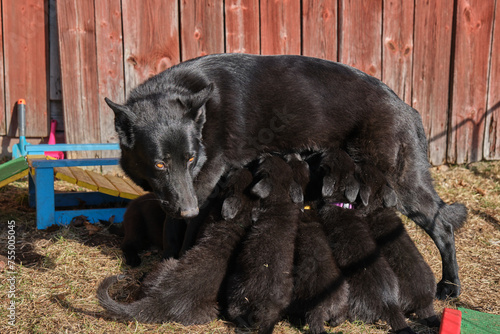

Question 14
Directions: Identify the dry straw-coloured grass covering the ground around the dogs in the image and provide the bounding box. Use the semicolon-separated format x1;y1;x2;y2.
0;162;500;334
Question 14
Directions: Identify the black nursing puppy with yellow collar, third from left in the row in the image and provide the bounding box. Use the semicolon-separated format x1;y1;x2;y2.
286;155;349;334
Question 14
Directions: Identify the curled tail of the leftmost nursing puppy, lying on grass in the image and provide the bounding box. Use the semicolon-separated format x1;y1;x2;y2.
97;275;161;323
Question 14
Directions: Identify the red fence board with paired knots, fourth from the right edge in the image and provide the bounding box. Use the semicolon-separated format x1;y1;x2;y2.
382;0;414;105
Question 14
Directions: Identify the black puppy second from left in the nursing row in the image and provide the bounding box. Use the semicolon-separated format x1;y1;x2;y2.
226;155;303;334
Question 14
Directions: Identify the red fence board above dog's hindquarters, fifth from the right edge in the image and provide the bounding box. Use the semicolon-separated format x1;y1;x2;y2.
339;0;382;79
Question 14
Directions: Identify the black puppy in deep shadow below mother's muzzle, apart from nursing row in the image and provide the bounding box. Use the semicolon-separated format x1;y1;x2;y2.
121;193;167;267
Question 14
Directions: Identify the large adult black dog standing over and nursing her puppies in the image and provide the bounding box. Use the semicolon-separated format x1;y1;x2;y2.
106;54;466;298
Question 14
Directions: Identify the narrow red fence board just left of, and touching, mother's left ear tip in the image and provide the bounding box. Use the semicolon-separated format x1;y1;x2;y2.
95;0;125;161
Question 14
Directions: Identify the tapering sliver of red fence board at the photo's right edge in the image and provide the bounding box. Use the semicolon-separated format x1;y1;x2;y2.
484;0;500;159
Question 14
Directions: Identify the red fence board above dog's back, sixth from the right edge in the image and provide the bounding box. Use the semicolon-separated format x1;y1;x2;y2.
302;0;338;61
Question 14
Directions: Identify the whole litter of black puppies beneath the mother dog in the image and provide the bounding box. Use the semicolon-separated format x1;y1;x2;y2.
97;149;439;334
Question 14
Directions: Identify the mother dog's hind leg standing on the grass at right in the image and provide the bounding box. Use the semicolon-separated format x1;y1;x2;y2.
395;169;467;299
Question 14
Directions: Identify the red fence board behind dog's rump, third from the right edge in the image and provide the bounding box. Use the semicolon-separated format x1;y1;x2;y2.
412;0;453;165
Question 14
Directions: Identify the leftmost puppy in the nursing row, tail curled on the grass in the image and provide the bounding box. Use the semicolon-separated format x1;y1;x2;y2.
97;169;255;325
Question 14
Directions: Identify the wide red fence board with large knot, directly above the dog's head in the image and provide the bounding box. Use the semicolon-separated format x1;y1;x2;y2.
122;0;180;96
